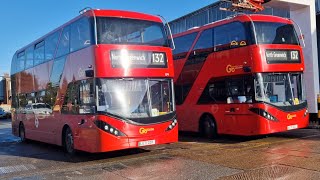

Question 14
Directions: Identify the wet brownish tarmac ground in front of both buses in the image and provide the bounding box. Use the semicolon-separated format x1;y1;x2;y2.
0;120;320;180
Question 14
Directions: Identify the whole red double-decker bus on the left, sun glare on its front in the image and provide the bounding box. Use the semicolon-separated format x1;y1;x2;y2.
11;10;178;153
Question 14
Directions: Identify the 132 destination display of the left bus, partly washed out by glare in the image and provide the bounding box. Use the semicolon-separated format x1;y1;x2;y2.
110;50;167;68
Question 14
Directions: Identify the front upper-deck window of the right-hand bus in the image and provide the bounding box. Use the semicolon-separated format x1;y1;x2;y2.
254;22;299;45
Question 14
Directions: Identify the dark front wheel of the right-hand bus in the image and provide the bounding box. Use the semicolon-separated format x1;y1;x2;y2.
200;115;217;139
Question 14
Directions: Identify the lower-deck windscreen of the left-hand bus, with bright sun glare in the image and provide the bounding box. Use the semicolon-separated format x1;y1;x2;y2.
96;78;175;119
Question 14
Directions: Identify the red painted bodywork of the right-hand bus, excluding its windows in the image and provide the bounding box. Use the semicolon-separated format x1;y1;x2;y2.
174;15;308;136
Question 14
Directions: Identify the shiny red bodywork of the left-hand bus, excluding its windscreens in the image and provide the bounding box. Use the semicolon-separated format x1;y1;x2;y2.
11;10;178;153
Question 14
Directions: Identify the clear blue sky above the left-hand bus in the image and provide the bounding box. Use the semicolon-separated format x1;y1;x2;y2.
0;0;216;75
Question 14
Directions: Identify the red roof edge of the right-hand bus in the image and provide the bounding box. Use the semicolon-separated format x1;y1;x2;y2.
173;14;293;38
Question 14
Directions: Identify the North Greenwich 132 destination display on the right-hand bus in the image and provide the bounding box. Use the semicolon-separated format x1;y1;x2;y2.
266;50;301;64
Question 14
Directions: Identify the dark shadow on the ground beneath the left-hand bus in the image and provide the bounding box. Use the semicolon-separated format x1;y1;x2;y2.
0;140;149;163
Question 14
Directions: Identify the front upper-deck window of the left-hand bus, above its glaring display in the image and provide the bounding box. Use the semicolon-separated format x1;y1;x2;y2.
97;17;169;46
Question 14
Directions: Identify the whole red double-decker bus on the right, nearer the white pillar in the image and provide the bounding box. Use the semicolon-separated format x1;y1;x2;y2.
173;15;308;137
